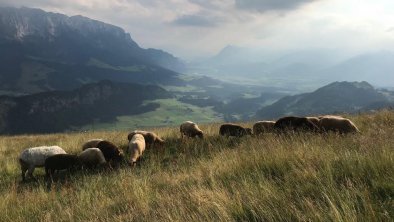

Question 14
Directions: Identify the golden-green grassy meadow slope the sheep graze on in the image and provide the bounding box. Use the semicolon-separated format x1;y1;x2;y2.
0;111;394;221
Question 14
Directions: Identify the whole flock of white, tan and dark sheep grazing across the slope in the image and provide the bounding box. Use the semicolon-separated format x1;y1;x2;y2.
19;115;360;186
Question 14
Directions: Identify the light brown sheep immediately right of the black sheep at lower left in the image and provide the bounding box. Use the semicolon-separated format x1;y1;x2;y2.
78;148;107;169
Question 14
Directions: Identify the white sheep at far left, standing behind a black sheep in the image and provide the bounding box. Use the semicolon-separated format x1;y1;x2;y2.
19;146;66;181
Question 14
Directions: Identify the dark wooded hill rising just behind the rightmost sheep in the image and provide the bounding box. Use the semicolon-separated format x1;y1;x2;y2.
256;82;390;118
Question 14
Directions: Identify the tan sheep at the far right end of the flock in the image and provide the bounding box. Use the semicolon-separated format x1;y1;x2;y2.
320;116;360;134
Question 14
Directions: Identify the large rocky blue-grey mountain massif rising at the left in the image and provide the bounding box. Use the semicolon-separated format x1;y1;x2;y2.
0;7;183;93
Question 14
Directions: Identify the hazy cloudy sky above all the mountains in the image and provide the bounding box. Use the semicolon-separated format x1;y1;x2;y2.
0;0;394;58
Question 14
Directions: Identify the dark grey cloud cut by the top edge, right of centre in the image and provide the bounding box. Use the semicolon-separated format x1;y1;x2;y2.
235;0;316;13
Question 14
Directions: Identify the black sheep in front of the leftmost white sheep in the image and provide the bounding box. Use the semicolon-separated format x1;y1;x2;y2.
45;154;80;179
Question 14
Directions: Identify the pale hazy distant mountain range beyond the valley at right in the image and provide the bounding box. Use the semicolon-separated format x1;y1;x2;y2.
189;46;394;92
